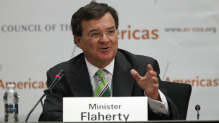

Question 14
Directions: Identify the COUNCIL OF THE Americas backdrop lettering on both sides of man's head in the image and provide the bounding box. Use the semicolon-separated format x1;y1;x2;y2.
0;24;159;40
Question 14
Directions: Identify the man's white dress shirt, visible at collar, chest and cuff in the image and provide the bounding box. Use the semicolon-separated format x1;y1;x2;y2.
85;58;168;114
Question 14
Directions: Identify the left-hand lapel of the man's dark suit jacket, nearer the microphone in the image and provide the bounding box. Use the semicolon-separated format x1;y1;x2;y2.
66;55;92;97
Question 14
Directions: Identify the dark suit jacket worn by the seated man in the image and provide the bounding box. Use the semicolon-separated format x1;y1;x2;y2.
39;49;178;121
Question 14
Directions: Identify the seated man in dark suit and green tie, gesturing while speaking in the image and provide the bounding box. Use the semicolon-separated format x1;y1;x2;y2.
39;2;178;121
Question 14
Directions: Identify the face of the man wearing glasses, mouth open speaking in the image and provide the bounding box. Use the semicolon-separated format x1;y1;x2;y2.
74;12;118;68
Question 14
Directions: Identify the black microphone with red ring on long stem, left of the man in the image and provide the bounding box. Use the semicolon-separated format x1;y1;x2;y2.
25;70;64;122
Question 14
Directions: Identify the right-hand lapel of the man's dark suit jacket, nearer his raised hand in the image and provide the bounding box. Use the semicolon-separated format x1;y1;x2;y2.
112;51;134;96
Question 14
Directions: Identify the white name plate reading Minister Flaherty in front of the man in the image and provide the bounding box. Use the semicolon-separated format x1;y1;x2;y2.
63;97;148;122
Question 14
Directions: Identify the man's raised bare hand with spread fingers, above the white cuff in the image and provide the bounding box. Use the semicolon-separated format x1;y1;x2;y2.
130;64;160;101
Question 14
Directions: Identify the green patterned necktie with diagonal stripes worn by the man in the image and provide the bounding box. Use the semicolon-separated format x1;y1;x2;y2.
94;69;111;97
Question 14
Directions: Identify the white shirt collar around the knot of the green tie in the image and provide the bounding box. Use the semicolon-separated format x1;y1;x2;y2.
85;58;115;80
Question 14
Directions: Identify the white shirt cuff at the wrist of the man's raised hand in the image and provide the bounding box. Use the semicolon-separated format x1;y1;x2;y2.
148;90;169;114
